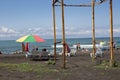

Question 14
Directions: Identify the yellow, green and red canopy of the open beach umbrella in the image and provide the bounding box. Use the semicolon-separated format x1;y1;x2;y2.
16;34;45;42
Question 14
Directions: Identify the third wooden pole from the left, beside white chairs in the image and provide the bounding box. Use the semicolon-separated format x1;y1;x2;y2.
92;0;96;62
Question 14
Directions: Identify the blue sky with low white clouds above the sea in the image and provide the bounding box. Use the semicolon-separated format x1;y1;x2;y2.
0;0;120;40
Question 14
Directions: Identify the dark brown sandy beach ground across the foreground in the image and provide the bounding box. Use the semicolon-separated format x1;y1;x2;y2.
0;50;120;80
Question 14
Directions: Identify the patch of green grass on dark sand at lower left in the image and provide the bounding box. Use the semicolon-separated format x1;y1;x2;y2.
0;63;55;73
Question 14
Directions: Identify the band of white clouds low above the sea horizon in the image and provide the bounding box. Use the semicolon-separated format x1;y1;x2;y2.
0;26;120;39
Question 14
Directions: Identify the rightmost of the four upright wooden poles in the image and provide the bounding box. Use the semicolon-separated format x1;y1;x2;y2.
110;0;114;66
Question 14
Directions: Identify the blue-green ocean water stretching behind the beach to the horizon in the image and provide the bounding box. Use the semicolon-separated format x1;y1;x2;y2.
0;37;120;54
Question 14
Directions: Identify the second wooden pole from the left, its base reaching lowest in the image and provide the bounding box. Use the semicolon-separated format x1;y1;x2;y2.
61;0;66;69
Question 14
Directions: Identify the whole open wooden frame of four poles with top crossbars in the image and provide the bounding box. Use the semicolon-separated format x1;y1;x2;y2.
52;0;114;69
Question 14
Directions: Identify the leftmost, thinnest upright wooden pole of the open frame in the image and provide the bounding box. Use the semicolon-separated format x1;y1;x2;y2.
52;0;56;64
